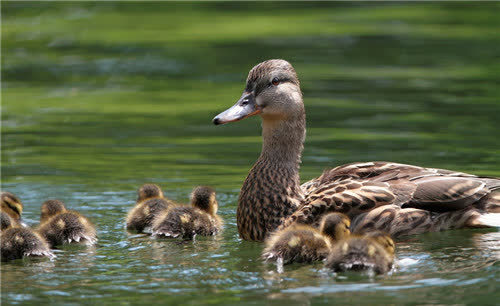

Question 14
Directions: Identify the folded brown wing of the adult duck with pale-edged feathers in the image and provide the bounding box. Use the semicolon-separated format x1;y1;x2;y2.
292;162;500;227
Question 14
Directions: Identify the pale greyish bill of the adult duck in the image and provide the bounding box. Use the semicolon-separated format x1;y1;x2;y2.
213;92;261;125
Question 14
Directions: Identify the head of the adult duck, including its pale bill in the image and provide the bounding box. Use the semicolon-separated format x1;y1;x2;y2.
213;59;304;125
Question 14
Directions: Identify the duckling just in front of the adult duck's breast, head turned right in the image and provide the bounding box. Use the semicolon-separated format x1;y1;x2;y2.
262;213;351;264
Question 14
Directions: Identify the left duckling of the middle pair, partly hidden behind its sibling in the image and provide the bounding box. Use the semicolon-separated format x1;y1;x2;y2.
126;184;172;233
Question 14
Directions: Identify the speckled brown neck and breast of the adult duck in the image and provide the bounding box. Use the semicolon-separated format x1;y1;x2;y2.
236;113;306;241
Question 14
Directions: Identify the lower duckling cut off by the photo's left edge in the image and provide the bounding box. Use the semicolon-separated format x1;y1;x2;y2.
0;211;55;261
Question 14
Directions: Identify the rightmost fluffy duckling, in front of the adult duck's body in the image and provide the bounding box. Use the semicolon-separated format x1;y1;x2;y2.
325;231;395;274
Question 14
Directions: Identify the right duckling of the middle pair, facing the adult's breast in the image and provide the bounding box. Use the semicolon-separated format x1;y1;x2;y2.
152;186;223;239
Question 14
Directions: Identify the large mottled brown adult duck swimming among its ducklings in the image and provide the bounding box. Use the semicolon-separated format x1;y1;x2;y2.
213;59;500;241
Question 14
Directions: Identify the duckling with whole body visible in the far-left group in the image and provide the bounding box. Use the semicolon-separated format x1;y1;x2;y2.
38;200;97;247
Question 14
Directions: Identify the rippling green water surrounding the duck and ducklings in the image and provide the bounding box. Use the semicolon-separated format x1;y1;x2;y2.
0;2;500;305
